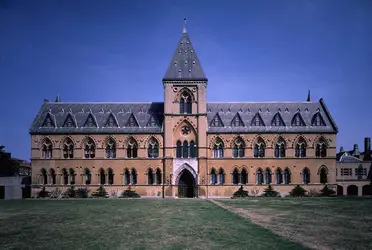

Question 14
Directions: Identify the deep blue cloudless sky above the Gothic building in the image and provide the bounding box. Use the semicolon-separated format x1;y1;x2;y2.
0;0;372;159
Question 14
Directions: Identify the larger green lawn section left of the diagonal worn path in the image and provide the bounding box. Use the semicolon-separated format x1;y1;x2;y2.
0;199;304;250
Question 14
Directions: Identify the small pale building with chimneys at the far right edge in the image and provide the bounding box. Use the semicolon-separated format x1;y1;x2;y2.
336;137;372;196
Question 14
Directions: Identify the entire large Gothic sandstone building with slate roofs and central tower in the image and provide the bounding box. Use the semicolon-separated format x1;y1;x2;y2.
30;24;338;197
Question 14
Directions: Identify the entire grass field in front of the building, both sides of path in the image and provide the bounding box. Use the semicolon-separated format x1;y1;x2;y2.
0;198;372;250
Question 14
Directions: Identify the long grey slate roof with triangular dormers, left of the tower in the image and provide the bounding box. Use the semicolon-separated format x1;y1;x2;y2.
30;102;164;134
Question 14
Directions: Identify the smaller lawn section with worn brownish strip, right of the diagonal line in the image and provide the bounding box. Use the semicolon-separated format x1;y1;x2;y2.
218;197;372;249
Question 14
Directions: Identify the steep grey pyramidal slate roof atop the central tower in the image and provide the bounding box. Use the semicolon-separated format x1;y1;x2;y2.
163;21;207;81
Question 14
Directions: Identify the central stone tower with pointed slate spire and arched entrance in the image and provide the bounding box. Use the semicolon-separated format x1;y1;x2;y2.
163;19;208;196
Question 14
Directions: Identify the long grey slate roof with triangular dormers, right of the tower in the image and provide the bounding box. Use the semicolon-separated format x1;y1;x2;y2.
207;99;338;133
